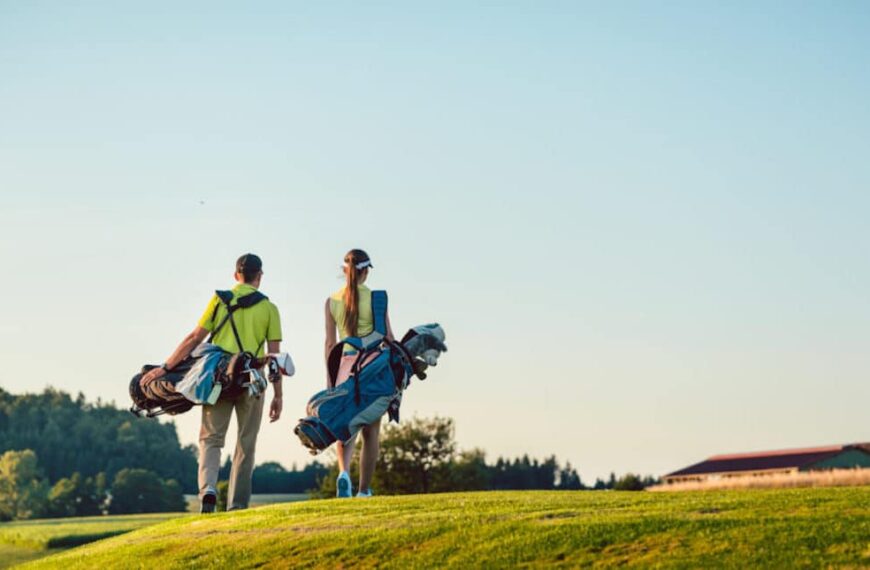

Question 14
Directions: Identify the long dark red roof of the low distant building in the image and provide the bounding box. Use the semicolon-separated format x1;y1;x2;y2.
666;443;870;477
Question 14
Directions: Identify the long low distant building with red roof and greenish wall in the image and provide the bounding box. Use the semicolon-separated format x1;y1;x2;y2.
662;443;870;483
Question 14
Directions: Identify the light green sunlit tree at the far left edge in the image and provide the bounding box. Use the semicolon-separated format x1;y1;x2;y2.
0;449;48;520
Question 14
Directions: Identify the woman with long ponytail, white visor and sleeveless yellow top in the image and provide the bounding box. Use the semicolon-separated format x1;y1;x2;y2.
325;249;393;497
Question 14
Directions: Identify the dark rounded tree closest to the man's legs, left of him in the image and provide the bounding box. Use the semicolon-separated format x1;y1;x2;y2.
109;469;187;514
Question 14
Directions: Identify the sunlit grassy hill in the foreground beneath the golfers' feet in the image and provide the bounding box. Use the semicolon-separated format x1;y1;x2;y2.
15;487;870;569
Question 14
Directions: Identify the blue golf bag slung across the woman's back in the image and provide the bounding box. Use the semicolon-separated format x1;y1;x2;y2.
293;291;415;455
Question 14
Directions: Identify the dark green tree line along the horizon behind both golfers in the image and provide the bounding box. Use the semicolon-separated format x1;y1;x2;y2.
0;388;656;519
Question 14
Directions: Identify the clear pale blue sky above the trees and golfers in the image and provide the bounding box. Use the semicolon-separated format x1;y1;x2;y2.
0;1;870;481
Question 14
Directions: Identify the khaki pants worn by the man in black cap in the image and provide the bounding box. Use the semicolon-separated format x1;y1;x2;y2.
199;392;265;509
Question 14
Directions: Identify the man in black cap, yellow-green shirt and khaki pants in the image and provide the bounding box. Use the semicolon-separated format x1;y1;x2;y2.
143;253;282;513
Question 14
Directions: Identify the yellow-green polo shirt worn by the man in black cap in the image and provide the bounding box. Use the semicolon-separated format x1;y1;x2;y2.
199;283;281;356
